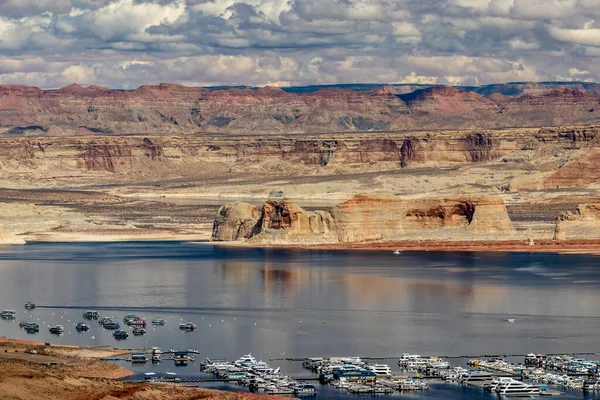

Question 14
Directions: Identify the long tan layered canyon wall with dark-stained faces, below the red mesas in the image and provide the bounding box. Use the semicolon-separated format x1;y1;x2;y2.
0;127;600;188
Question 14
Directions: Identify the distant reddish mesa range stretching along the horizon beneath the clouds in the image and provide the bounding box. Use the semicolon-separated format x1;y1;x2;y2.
0;84;600;136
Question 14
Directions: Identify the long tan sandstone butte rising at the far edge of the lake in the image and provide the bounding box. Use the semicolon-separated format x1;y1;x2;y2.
212;195;514;243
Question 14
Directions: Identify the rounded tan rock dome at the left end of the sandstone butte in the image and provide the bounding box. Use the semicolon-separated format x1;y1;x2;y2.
212;202;259;241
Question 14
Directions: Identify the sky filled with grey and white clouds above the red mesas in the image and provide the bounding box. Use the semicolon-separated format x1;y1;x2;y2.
0;0;600;89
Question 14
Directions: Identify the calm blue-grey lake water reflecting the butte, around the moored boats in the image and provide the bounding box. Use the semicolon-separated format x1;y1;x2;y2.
0;243;600;399
